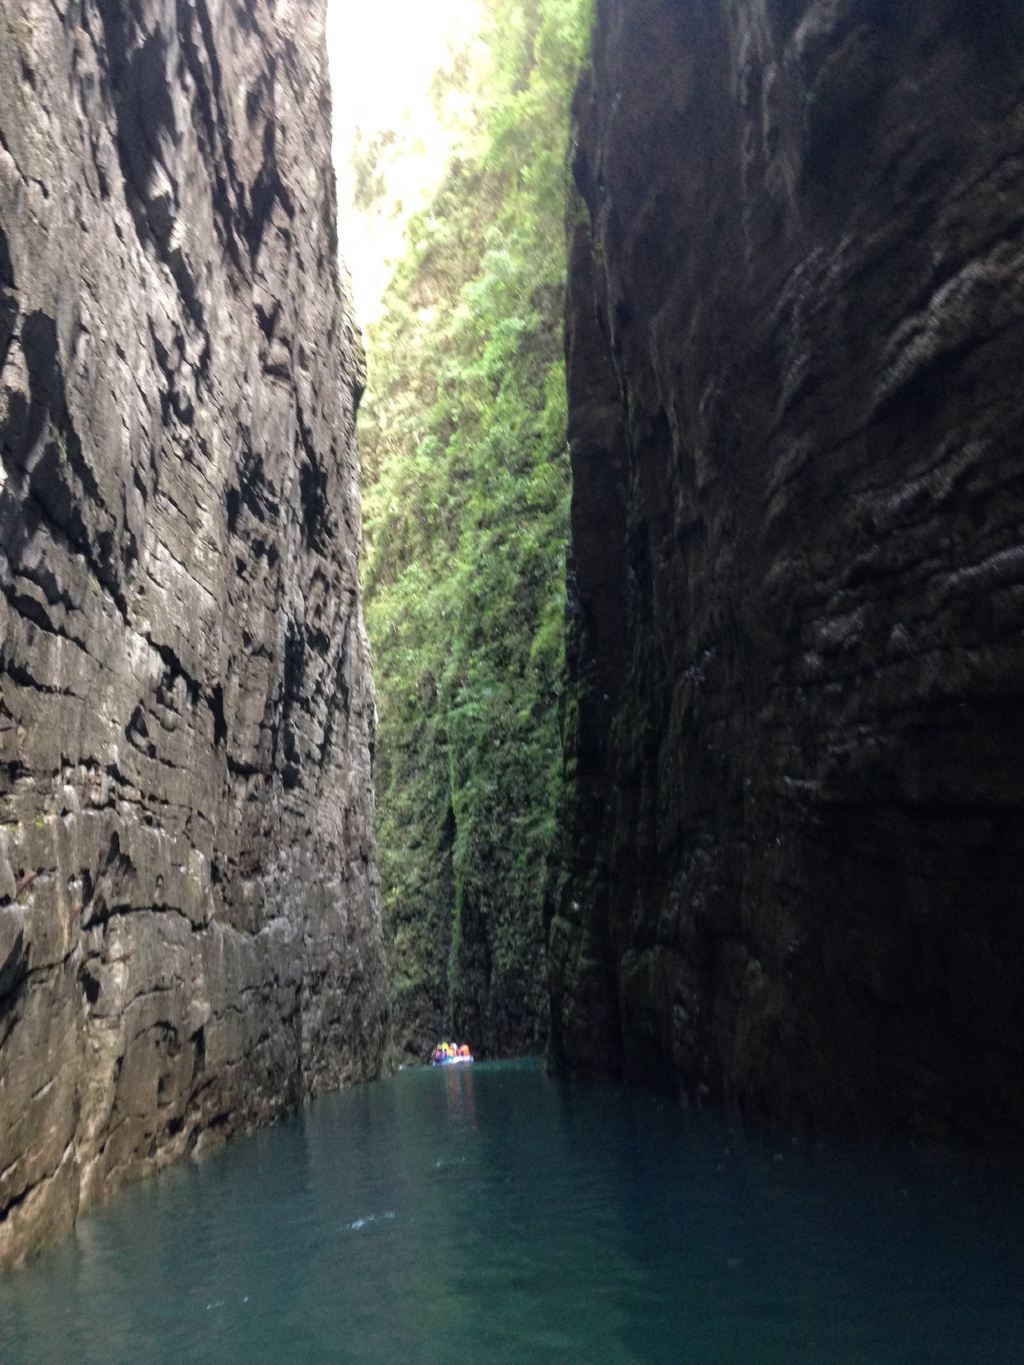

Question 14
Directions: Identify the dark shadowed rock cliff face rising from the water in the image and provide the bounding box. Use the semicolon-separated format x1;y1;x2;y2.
550;0;1024;1141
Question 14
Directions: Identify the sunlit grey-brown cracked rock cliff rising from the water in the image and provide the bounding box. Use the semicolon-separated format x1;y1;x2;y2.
0;0;386;1263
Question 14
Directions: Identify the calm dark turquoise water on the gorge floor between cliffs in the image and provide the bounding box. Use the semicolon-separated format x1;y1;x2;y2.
0;1062;1024;1365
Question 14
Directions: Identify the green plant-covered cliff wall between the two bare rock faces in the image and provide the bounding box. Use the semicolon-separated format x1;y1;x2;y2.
360;0;590;1054
